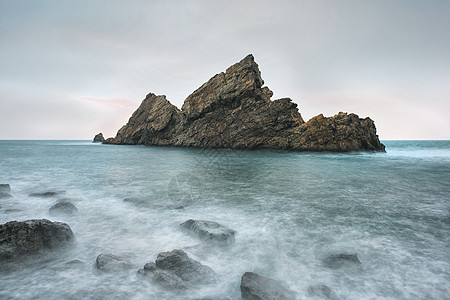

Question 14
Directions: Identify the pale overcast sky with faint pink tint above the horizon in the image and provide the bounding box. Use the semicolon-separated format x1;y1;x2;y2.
0;0;450;139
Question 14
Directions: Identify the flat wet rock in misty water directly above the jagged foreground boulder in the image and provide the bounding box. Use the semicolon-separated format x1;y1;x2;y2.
180;219;236;245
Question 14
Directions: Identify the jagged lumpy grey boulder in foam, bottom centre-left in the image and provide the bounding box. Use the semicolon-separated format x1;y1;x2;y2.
139;250;216;289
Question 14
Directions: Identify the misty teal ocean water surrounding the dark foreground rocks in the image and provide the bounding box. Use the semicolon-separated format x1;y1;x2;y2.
0;141;450;299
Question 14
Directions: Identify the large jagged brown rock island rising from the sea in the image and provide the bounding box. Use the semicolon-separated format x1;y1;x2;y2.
105;55;384;152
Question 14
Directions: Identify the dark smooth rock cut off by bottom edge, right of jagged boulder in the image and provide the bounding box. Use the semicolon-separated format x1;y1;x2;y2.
241;272;295;300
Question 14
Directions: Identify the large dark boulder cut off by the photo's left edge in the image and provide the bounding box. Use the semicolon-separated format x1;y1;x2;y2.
0;219;74;262
